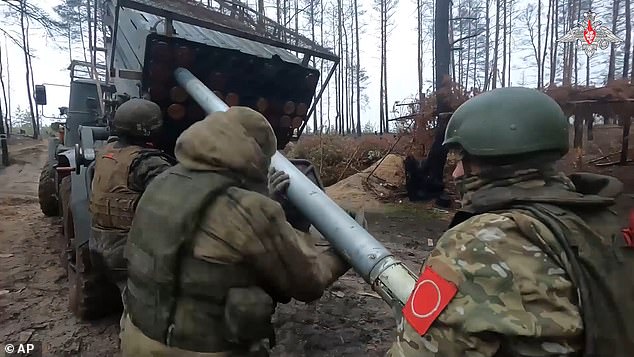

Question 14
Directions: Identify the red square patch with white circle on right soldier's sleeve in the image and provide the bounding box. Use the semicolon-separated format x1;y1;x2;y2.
403;267;458;336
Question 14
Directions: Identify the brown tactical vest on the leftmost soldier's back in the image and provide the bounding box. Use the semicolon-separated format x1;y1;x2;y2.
90;143;146;231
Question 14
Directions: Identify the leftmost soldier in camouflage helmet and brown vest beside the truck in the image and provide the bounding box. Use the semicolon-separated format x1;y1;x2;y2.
90;99;173;290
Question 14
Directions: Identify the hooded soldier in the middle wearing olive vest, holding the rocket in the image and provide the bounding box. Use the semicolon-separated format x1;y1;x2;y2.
121;107;365;357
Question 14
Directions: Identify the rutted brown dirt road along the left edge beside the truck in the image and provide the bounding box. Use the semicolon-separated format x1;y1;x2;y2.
0;140;117;356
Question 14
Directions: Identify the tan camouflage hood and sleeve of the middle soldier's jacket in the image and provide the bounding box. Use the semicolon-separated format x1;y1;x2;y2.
175;107;349;302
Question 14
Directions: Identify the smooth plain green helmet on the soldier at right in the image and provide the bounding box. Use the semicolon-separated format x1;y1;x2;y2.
443;87;569;158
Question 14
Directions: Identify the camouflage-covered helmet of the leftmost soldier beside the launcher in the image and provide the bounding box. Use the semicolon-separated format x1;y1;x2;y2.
112;98;163;137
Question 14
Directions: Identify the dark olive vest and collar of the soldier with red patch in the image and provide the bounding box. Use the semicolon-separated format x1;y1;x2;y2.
451;176;634;357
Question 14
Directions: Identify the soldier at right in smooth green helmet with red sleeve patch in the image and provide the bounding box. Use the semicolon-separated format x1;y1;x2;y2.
387;88;634;357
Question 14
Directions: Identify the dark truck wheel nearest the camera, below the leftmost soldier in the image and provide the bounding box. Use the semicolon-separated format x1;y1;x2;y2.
68;244;123;320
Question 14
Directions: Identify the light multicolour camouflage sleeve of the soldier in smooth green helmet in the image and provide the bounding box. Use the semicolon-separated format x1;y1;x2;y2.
387;214;583;357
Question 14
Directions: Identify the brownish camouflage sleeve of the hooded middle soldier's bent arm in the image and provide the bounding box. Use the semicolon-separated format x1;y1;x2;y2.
194;187;348;302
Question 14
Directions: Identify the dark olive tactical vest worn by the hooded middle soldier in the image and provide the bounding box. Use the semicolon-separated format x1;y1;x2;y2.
124;165;272;352
